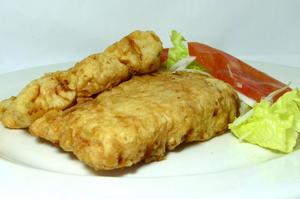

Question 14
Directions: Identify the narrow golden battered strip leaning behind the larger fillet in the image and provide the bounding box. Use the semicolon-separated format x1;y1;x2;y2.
0;31;162;128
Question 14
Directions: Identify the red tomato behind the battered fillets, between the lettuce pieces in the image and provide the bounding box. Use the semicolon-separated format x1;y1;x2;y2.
161;42;291;101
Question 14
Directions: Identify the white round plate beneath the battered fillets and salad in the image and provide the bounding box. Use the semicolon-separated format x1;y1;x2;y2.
0;62;300;198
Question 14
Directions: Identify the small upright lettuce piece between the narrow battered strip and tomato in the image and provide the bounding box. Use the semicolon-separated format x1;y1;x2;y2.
166;30;189;69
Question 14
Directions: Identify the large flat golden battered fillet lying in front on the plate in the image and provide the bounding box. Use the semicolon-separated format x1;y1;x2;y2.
29;72;240;170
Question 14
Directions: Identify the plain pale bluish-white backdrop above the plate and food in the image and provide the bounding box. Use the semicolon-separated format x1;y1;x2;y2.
0;0;300;73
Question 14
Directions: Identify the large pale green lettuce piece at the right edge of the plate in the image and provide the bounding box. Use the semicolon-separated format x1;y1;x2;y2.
229;88;300;153
